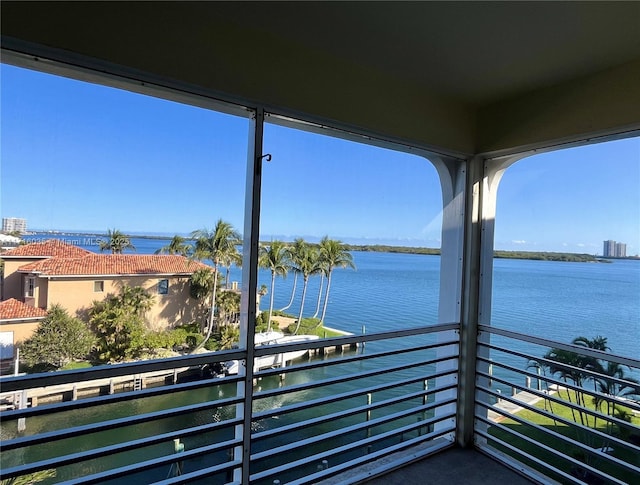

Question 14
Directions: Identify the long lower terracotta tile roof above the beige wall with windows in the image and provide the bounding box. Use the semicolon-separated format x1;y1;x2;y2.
18;253;212;276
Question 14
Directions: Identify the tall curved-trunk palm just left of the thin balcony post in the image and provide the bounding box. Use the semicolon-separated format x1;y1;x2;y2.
191;219;241;351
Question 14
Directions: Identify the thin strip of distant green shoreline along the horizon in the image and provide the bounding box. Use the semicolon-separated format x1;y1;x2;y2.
27;231;640;263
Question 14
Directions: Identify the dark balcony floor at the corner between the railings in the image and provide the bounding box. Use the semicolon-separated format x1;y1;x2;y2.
366;448;536;485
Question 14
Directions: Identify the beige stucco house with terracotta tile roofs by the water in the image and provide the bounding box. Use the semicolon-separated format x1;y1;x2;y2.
0;239;211;330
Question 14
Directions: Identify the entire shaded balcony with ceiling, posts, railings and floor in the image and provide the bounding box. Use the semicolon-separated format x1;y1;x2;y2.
0;1;640;484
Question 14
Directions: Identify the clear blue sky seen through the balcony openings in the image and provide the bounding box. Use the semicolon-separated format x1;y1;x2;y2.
0;65;640;254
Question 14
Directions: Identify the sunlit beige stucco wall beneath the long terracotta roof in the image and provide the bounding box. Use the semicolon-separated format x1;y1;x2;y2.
41;276;201;330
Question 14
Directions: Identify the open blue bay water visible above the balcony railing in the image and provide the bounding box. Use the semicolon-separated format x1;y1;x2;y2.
22;236;640;358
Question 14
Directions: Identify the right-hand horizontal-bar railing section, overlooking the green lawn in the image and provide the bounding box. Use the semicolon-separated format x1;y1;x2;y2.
475;327;640;484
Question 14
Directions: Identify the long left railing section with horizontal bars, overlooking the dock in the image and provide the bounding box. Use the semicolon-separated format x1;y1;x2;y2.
1;324;459;484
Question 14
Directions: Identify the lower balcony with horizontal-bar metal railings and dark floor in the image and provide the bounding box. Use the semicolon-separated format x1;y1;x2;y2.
2;323;640;484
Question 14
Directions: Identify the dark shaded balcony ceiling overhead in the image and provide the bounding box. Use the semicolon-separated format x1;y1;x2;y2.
2;1;640;154
